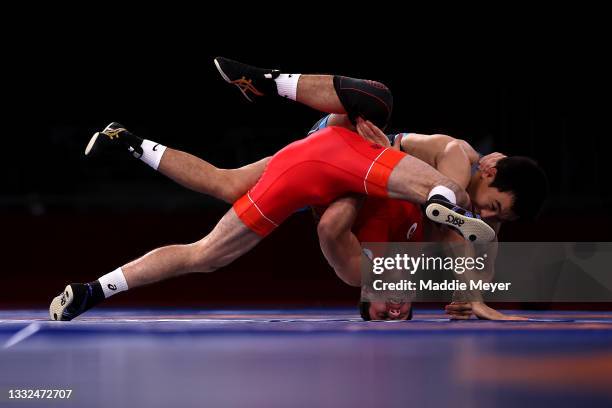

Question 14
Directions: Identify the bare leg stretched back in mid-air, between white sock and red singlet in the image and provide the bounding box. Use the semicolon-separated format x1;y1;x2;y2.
158;148;270;203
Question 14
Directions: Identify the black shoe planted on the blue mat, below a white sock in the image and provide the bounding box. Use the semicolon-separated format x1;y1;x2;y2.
49;283;97;321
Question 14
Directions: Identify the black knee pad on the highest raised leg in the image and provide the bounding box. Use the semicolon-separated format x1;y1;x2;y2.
334;76;393;129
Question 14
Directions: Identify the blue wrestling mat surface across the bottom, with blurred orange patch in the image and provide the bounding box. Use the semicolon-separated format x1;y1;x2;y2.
0;309;612;407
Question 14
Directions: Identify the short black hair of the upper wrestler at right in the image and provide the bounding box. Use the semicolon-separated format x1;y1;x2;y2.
491;156;548;219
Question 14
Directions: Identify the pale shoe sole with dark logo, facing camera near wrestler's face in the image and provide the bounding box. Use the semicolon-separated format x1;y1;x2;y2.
425;203;495;242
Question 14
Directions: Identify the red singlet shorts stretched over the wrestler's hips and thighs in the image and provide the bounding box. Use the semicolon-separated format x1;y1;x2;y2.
234;126;406;236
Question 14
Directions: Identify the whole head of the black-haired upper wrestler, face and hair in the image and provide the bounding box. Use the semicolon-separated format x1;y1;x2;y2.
467;156;548;221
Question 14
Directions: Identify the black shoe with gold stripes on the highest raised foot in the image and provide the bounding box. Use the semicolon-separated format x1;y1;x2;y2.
215;57;280;102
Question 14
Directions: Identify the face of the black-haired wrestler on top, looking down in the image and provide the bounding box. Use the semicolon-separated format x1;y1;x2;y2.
470;168;516;221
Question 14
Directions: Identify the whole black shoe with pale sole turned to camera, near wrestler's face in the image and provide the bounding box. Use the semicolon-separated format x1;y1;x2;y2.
425;196;495;242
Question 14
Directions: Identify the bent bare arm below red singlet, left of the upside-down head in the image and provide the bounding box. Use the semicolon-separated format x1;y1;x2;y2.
317;196;364;286
